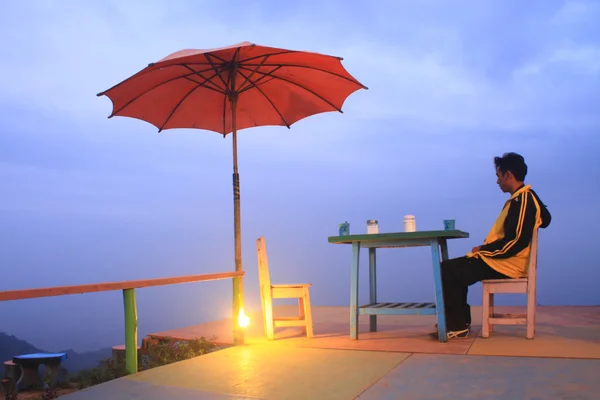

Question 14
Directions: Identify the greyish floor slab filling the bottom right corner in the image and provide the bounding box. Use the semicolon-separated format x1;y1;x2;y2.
358;354;600;400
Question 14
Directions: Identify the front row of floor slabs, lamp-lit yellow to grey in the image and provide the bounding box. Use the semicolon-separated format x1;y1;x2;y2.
61;345;600;400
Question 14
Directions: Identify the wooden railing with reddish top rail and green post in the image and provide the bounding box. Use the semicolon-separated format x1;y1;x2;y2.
0;271;245;374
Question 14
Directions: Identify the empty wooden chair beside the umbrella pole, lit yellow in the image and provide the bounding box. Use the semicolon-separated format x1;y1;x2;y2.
256;236;314;340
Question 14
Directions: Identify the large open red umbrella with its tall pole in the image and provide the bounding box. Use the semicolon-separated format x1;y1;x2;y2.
98;42;367;340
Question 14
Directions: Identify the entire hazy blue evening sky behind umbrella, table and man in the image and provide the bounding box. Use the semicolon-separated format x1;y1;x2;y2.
0;0;600;351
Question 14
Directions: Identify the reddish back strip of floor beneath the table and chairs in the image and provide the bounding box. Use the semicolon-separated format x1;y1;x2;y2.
150;306;600;359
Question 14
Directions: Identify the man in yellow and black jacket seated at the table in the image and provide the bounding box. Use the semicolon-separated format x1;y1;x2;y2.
431;153;551;339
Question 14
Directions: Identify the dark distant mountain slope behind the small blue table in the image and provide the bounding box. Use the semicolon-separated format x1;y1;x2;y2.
0;332;111;373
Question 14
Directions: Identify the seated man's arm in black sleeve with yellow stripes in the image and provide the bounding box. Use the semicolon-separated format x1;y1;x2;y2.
473;192;537;258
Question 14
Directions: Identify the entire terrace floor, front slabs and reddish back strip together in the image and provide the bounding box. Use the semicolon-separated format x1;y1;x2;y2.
61;307;600;400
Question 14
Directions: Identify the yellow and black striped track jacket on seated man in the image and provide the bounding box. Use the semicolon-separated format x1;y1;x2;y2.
467;185;552;278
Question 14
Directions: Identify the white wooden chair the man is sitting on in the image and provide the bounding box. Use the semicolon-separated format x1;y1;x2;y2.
481;229;538;339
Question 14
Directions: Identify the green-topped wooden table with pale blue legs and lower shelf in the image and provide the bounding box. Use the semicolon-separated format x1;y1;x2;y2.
328;230;469;342
